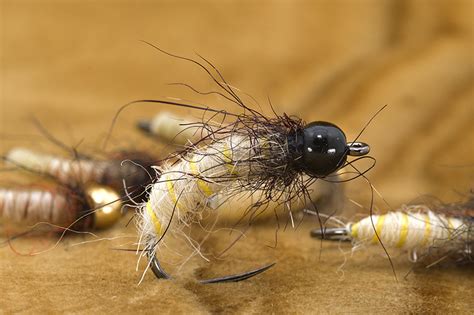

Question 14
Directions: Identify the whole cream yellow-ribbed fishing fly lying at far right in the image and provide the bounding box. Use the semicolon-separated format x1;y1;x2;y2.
311;204;474;267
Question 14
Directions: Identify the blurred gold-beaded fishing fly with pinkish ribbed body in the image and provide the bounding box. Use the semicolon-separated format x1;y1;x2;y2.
0;184;121;231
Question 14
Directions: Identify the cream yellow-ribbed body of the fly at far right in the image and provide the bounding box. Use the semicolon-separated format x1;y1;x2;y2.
347;207;472;250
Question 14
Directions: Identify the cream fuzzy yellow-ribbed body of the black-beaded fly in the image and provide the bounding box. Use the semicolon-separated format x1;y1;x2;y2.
141;135;269;242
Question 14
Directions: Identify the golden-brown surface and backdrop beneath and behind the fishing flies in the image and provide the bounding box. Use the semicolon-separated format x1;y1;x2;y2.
0;0;474;314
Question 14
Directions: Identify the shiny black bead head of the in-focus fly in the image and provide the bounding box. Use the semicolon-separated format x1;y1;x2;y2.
302;121;348;177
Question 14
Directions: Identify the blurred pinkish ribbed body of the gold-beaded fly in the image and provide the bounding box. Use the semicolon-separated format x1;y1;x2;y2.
0;188;82;226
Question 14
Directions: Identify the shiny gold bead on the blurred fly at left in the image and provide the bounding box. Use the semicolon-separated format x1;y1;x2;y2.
85;184;122;229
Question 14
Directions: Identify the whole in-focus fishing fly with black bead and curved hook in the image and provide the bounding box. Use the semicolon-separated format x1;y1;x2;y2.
105;44;375;283
